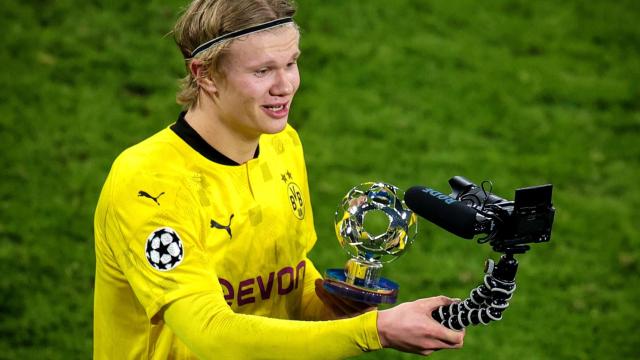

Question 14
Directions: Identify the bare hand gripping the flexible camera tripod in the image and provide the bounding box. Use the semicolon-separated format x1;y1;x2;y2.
378;296;465;355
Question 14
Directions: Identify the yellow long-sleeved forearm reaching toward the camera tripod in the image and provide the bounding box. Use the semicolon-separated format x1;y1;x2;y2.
164;293;381;359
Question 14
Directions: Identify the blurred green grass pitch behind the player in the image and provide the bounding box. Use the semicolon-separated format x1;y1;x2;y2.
0;0;640;359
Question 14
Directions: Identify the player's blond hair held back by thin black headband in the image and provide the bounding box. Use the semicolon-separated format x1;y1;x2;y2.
173;0;296;109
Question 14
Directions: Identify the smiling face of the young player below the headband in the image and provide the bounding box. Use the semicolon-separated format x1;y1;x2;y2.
213;25;300;140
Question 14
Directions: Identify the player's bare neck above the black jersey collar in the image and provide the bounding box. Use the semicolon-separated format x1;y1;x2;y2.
185;101;260;164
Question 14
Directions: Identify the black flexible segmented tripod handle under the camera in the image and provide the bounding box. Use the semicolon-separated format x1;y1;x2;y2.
431;252;518;330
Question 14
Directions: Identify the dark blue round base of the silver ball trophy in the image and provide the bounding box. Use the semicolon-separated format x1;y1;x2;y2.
324;269;398;305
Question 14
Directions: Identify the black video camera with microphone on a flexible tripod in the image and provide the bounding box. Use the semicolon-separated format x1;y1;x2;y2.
405;176;555;330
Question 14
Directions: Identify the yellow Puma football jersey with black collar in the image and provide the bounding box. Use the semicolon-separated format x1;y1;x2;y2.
94;113;380;359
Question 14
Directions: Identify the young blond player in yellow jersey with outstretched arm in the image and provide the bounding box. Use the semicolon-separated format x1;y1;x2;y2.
94;0;464;359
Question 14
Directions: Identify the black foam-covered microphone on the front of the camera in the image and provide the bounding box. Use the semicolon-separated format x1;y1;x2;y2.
404;186;478;239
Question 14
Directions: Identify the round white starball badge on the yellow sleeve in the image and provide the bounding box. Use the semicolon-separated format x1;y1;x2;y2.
145;227;184;271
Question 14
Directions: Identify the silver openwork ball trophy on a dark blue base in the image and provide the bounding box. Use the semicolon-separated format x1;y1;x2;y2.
324;182;417;304
